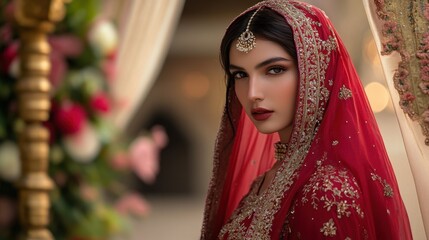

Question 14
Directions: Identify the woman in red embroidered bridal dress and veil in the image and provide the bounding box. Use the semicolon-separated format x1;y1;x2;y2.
201;0;412;239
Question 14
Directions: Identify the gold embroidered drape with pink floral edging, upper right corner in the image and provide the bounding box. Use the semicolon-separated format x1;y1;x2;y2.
374;0;429;146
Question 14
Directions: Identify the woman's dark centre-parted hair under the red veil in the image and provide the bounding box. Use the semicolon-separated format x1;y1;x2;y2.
220;8;298;133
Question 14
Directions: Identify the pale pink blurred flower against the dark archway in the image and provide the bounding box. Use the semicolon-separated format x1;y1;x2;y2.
129;137;159;183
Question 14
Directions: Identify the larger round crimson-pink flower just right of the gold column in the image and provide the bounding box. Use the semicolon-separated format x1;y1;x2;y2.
54;103;86;135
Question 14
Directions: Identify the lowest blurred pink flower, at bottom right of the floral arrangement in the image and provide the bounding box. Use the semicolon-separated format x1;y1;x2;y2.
115;193;150;216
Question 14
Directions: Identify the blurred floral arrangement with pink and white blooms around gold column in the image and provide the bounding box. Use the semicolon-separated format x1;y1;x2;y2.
0;0;167;240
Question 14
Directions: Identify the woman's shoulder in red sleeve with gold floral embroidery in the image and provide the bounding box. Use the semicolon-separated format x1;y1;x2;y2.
285;165;365;239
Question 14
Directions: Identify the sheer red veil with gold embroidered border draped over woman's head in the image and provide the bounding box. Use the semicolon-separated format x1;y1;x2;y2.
201;0;412;239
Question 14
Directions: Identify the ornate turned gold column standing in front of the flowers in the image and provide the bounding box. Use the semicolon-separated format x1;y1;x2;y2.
15;0;68;240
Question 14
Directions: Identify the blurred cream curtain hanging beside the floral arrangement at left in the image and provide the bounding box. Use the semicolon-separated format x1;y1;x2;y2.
106;0;185;129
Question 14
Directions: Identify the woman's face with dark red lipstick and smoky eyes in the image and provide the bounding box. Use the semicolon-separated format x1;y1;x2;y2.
230;38;299;141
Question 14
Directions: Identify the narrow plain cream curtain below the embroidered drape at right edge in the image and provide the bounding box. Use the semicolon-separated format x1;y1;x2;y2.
363;0;429;236
